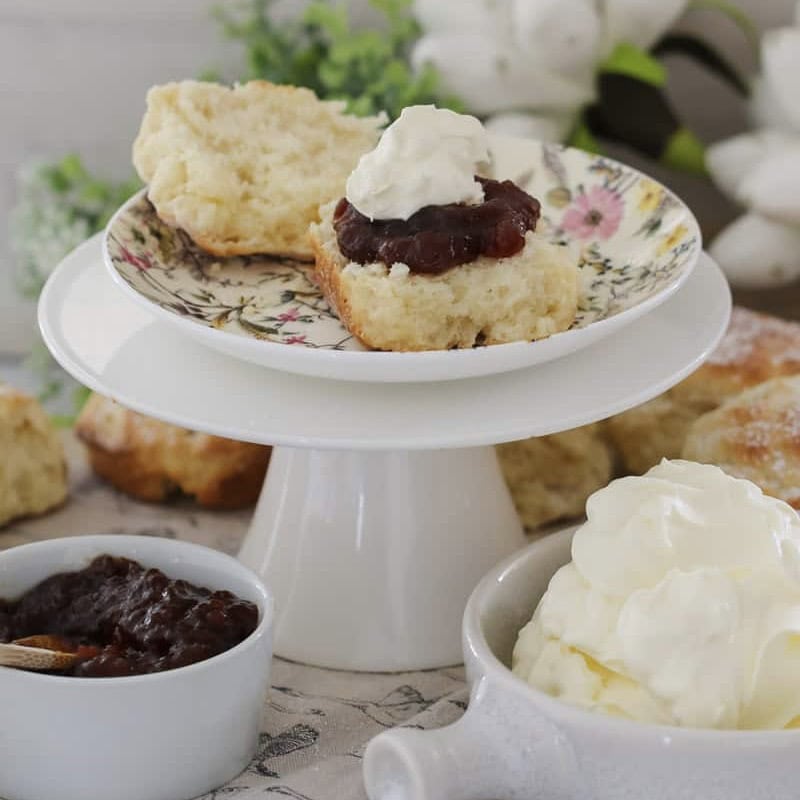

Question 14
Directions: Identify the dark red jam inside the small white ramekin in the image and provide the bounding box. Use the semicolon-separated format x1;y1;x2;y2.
0;555;258;678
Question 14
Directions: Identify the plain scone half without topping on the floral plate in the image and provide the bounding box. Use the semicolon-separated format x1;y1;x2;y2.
133;81;383;259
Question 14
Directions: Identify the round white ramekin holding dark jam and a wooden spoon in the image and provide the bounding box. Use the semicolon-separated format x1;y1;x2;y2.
0;535;273;800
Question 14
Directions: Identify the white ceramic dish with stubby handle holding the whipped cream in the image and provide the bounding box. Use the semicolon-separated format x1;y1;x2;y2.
364;530;800;800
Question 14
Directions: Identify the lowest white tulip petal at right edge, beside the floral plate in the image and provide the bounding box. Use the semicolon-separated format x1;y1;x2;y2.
709;214;800;289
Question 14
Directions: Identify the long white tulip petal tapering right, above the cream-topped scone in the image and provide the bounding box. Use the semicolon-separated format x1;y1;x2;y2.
411;33;593;114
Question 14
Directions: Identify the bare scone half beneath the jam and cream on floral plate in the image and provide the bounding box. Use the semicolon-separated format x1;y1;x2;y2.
311;203;578;351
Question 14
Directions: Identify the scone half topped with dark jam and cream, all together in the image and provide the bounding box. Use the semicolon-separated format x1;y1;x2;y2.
310;106;578;351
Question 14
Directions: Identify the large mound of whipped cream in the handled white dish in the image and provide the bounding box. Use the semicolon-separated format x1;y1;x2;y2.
513;461;800;729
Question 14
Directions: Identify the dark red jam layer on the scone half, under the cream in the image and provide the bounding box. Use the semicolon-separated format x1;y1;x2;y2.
333;175;540;274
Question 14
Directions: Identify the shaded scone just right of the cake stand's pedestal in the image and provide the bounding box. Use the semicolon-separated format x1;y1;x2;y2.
496;424;614;530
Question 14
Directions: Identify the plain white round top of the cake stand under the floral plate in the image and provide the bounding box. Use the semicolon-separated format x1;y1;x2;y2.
39;237;731;450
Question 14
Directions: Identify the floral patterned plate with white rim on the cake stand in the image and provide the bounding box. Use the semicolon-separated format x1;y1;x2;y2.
104;136;701;382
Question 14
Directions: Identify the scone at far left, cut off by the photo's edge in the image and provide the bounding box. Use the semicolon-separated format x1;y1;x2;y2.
0;385;67;525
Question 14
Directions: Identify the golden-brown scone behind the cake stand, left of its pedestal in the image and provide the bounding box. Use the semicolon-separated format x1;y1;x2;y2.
75;394;270;509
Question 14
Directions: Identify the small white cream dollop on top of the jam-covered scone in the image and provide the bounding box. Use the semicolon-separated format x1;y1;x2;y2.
346;106;490;220
